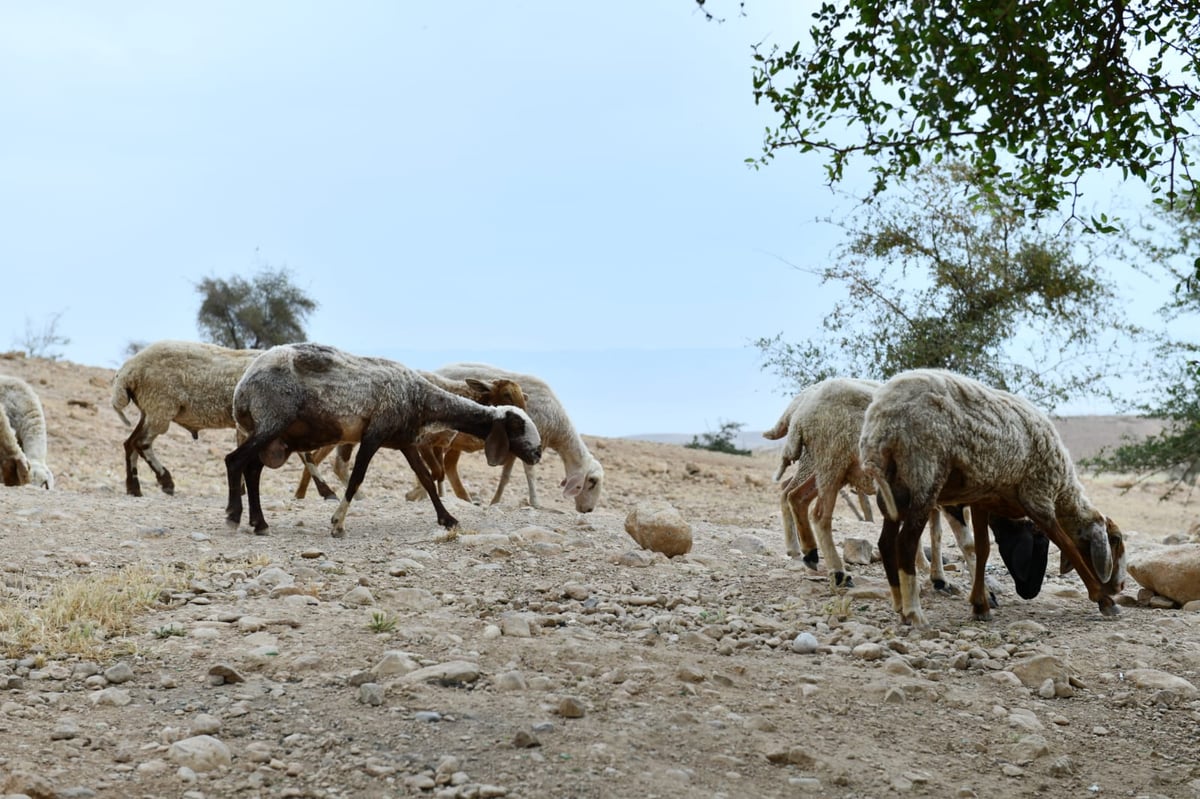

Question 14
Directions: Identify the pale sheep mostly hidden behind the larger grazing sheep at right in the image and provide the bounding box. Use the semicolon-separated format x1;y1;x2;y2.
763;378;974;591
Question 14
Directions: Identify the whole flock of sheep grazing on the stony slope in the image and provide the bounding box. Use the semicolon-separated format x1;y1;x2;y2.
0;341;1126;626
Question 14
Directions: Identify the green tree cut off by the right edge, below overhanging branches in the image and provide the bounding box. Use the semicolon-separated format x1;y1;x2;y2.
1082;202;1200;499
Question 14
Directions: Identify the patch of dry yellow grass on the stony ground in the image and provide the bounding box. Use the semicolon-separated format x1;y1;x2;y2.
0;566;181;660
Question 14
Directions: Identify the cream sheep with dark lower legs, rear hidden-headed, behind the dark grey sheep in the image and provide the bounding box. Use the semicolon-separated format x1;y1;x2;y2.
113;340;332;497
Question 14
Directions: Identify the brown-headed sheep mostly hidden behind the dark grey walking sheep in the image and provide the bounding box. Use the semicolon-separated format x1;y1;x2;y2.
295;370;526;500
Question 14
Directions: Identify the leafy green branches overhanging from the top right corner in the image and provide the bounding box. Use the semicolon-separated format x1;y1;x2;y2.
696;0;1200;220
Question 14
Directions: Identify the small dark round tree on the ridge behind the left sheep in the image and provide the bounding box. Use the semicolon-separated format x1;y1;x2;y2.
196;268;317;349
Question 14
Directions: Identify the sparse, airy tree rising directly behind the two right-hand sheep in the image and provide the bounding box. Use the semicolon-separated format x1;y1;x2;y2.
757;163;1140;407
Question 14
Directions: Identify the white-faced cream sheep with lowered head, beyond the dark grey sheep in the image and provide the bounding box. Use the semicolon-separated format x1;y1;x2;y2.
427;364;604;513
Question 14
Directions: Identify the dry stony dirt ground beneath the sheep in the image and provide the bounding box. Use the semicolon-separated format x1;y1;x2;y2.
0;359;1200;799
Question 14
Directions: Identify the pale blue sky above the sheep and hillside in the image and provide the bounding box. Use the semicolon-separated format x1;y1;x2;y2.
0;0;1176;435
